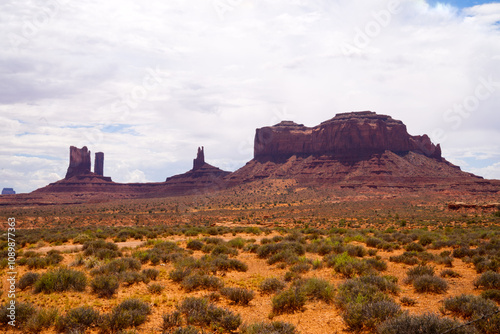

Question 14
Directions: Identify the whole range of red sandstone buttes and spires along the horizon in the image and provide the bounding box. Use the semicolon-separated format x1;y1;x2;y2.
4;111;500;204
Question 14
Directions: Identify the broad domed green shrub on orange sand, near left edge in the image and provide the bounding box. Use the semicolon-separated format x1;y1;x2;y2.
34;268;87;293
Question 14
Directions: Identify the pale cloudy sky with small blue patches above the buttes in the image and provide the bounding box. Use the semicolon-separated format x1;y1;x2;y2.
0;0;500;193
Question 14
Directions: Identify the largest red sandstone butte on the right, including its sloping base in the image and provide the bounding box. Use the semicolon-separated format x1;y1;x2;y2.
227;111;500;193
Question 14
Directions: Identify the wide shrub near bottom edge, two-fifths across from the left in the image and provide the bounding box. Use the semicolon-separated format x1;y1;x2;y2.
177;297;241;331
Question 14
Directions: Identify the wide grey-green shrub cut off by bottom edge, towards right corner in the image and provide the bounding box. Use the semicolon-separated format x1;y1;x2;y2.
377;313;478;334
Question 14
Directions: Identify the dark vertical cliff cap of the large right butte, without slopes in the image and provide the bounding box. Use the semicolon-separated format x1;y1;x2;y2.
254;111;441;162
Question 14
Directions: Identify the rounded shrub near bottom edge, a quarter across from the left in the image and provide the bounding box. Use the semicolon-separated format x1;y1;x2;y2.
100;299;151;332
